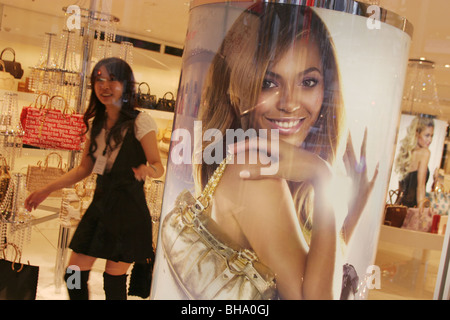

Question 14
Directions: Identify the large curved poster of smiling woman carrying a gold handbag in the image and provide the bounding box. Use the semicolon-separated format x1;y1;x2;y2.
152;1;411;300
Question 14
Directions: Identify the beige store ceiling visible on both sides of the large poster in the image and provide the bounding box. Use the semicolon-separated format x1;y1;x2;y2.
0;0;450;119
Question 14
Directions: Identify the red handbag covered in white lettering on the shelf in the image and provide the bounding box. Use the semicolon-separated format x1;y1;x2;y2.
20;96;86;151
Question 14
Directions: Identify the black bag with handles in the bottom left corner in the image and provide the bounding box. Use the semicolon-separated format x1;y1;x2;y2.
0;243;39;300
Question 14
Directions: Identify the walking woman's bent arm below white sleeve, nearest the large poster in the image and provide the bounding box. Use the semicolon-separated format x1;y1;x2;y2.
133;131;164;181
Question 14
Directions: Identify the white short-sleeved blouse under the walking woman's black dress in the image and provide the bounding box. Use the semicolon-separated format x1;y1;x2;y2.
88;111;158;172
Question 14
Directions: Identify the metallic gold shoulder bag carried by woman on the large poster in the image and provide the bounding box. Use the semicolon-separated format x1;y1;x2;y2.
161;158;277;300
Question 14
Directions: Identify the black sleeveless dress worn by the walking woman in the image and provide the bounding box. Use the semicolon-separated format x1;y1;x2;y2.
69;132;153;263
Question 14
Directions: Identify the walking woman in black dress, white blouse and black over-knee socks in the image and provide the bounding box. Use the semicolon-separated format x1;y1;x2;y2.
25;58;164;300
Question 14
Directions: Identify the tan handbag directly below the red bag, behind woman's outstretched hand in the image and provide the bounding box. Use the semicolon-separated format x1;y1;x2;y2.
26;152;67;197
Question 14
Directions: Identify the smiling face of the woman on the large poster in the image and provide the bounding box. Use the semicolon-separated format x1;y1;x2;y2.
250;39;324;146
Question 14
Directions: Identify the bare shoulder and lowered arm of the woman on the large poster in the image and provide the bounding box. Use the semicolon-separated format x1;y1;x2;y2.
215;160;337;299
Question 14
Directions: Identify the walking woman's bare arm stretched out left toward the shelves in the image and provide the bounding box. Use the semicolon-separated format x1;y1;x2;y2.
24;139;94;211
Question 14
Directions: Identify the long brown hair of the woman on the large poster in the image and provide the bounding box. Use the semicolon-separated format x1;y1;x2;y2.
194;3;344;240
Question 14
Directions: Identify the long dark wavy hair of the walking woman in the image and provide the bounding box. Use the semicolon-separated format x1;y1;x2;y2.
84;58;139;157
